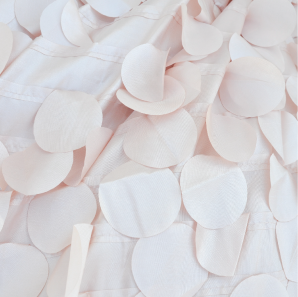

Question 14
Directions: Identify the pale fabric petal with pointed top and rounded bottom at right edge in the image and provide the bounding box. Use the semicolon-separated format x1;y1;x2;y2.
269;154;298;222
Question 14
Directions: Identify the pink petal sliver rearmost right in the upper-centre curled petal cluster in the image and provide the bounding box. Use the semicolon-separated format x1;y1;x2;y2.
166;62;201;106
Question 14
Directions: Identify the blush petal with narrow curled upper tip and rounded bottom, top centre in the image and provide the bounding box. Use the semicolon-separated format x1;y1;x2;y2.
181;4;223;56
